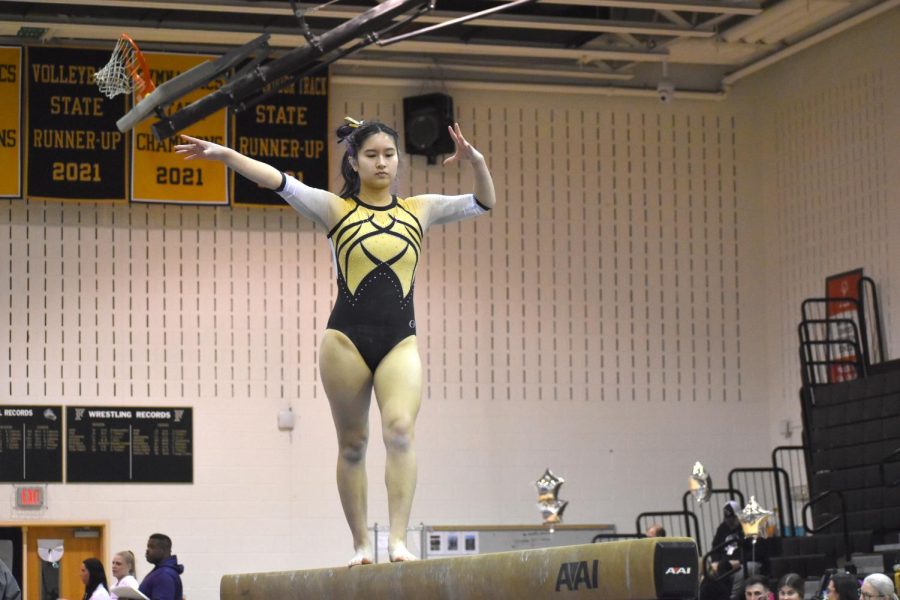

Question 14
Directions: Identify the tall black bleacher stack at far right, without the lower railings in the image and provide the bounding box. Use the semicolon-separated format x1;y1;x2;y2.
796;270;900;571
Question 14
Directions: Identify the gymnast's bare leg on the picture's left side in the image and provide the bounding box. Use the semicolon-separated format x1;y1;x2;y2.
319;329;373;567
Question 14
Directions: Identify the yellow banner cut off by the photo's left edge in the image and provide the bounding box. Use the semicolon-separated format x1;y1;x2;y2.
0;48;22;198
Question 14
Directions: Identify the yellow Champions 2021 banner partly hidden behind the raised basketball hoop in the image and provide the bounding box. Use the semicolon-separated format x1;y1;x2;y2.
131;52;228;204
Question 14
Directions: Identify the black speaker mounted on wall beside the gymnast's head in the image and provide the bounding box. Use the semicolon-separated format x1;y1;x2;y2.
403;94;454;165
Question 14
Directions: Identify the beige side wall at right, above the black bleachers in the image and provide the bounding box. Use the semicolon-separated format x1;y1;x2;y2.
733;9;900;443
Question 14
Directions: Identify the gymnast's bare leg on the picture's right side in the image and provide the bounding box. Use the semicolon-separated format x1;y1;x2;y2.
375;336;422;562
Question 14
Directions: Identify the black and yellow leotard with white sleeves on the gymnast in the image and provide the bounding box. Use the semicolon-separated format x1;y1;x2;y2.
278;172;487;373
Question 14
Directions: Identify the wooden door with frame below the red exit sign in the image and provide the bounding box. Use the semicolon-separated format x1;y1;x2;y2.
22;525;109;600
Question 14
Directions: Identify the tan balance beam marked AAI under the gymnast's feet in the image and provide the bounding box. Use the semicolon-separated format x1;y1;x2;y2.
220;538;699;600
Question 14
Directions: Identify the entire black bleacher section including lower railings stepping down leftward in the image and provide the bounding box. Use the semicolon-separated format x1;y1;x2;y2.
595;270;900;582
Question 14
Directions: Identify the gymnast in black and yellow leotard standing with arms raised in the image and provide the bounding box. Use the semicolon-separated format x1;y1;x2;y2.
175;117;496;567
